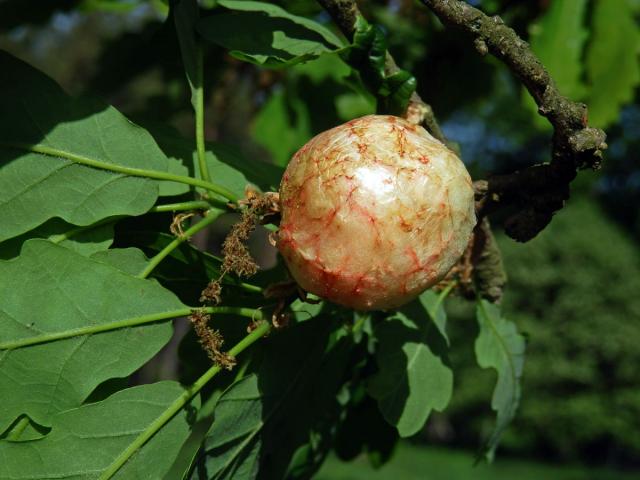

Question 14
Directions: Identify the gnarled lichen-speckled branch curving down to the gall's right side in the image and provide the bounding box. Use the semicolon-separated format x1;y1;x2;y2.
422;0;607;242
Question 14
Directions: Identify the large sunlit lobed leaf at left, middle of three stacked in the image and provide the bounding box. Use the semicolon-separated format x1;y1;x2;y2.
0;239;185;432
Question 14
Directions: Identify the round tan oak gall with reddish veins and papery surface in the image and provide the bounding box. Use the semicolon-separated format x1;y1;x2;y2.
277;115;476;310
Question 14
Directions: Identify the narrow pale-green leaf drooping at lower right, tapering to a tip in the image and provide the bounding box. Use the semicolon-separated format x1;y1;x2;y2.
475;299;525;460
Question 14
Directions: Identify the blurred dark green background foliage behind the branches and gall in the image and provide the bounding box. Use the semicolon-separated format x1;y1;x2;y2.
0;0;640;478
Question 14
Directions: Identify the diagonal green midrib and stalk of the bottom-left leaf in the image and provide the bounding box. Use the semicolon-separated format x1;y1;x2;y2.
99;322;271;480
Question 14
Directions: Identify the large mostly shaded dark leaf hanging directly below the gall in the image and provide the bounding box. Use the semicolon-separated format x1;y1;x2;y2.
199;317;352;480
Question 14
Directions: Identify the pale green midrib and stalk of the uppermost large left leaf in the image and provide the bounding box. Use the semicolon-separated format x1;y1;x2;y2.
0;142;238;202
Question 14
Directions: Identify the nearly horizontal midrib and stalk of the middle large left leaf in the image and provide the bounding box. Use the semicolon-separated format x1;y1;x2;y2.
0;307;262;350
